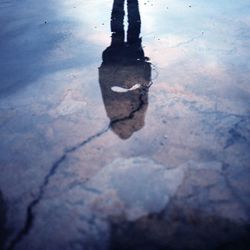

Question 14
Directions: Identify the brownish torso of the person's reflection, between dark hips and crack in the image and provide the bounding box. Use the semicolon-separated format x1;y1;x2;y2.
99;64;148;121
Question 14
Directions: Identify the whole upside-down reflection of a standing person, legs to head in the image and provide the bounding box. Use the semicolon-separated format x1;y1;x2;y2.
99;0;151;139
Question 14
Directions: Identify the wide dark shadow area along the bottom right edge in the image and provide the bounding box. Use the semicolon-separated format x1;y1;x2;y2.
109;209;250;250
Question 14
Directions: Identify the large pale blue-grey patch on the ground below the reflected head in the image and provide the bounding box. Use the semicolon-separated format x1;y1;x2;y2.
88;157;184;220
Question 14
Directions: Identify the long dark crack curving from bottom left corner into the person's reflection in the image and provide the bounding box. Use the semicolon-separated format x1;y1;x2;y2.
7;88;148;250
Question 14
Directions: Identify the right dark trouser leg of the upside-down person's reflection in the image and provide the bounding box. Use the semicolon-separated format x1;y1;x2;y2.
127;0;141;44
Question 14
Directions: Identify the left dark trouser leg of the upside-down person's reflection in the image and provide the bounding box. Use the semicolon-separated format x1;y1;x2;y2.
111;0;125;45
